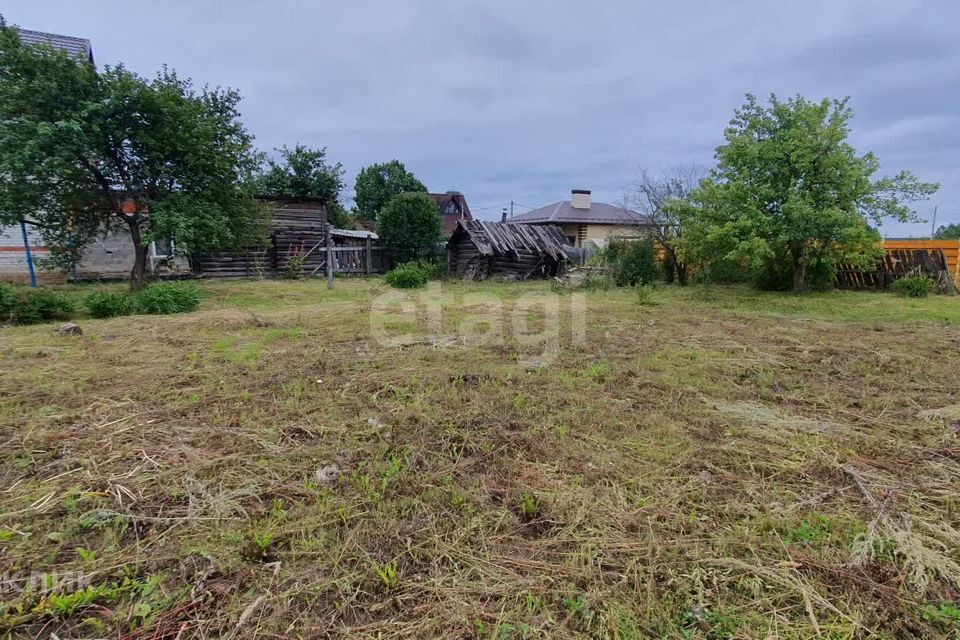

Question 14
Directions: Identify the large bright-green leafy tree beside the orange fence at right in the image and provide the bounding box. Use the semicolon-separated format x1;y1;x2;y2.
683;95;939;292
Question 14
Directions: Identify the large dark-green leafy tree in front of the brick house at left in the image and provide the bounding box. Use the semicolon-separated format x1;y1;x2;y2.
0;21;264;289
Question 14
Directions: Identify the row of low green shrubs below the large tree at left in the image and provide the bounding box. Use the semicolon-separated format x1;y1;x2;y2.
0;282;201;324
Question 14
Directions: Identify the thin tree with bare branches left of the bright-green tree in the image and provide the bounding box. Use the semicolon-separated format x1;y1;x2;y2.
626;165;706;286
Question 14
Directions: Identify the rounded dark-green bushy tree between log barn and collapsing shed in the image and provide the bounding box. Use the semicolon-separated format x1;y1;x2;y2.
377;193;443;263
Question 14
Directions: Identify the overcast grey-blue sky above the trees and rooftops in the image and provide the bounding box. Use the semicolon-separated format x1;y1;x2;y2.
0;0;960;236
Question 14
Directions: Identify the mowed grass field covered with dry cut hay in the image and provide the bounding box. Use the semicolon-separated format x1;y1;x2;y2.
0;279;960;639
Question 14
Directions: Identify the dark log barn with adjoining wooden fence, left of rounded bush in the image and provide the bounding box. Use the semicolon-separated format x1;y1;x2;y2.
197;200;390;278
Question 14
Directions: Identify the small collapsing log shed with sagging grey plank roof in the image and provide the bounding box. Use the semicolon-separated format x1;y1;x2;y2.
447;220;576;280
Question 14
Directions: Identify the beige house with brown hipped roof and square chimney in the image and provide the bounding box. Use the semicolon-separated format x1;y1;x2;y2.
509;189;653;247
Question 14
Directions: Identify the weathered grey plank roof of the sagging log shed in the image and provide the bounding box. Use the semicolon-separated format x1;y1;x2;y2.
450;220;576;260
